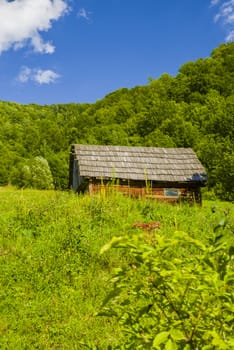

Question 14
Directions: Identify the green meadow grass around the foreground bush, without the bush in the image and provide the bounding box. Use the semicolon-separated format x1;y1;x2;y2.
0;187;233;350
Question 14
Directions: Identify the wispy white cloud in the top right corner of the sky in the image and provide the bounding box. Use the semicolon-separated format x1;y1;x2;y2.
211;0;234;41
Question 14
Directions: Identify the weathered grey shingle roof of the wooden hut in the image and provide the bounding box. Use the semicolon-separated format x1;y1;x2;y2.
72;145;206;182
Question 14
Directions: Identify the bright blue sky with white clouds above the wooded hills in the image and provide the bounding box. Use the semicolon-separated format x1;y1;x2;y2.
0;0;234;105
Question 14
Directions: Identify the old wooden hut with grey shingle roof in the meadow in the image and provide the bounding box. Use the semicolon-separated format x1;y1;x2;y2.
69;145;207;203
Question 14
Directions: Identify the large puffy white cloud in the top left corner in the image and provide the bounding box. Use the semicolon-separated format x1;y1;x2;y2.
0;0;68;54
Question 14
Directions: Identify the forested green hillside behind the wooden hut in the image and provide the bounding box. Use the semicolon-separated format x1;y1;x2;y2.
0;43;234;200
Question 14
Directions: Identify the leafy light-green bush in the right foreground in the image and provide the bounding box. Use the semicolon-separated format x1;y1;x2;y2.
99;209;234;350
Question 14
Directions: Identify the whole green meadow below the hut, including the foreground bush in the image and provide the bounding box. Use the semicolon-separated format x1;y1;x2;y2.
0;187;234;350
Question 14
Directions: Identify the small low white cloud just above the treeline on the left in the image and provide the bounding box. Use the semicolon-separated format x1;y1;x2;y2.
18;67;60;85
